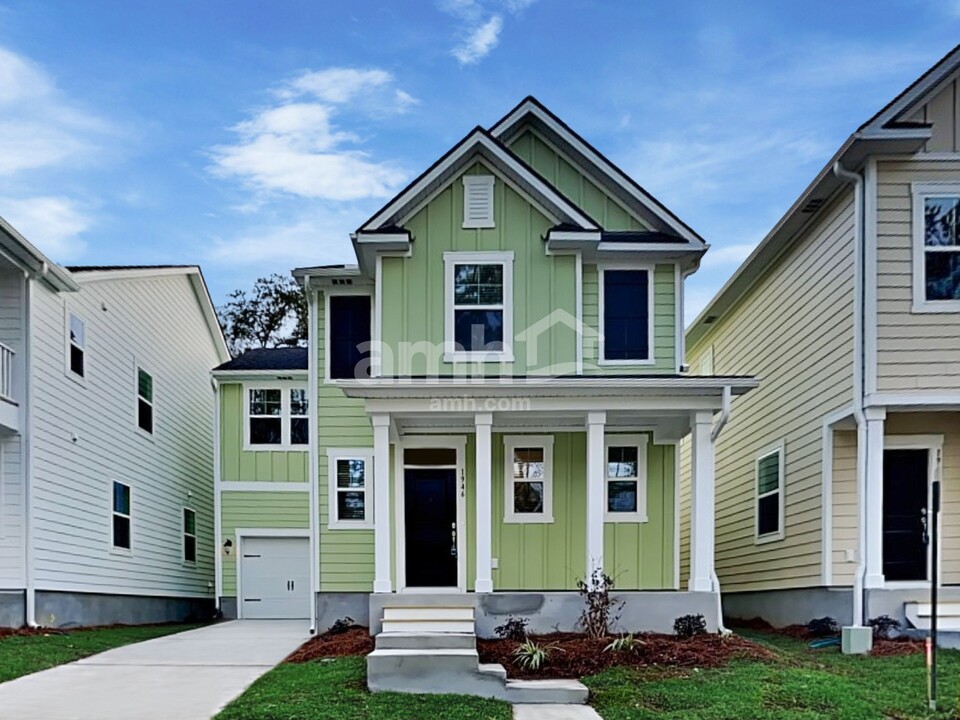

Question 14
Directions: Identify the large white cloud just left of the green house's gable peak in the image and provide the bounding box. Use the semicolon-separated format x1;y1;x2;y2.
211;68;417;201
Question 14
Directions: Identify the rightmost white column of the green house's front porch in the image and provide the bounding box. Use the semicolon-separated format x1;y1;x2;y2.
689;411;716;592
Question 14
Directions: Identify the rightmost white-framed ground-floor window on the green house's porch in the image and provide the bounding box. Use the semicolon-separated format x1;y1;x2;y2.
605;435;647;522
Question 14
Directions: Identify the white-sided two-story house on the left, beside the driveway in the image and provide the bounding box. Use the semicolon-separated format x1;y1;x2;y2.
0;220;229;626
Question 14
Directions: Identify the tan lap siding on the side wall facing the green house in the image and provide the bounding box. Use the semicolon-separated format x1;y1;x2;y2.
681;189;854;591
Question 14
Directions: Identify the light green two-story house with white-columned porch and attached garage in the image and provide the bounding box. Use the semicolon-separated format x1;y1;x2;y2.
214;98;755;635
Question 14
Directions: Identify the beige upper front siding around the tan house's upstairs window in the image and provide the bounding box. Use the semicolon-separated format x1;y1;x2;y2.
876;155;960;393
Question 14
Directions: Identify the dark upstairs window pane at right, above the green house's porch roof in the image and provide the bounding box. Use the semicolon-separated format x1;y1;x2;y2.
603;270;650;360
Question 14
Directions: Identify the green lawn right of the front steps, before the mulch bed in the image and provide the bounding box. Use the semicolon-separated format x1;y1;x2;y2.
585;632;960;720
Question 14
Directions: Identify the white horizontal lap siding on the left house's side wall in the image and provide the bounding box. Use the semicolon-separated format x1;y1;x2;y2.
31;274;220;604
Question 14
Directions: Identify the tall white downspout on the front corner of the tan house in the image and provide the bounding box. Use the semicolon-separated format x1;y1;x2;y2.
833;160;867;626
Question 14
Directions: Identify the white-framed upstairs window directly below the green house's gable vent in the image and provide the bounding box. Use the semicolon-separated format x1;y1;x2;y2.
443;252;513;362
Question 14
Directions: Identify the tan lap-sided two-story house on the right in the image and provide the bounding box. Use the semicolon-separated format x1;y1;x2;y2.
684;42;960;644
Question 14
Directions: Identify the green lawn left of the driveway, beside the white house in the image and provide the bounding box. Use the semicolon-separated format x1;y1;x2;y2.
0;624;200;682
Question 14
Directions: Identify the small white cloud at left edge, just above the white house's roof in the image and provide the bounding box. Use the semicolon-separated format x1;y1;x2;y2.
0;196;92;262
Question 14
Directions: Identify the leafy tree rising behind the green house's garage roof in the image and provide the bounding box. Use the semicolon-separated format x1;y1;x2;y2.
217;273;307;357
